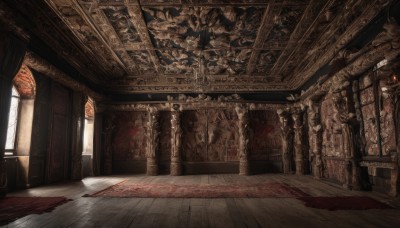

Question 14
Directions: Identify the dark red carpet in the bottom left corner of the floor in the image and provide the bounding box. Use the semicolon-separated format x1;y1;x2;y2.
0;197;70;226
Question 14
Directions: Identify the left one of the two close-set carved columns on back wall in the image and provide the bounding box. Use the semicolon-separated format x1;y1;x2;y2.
146;107;159;176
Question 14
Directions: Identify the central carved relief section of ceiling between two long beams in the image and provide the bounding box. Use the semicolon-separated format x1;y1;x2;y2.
143;6;264;75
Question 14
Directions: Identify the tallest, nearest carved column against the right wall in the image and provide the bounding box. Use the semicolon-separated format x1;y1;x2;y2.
333;82;361;190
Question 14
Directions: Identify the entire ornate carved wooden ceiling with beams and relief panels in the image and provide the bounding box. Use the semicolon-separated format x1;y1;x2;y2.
2;0;389;93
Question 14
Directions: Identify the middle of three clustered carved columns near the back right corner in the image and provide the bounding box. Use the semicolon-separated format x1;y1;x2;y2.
292;108;304;175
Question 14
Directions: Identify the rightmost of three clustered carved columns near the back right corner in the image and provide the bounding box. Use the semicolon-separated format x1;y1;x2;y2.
308;100;324;179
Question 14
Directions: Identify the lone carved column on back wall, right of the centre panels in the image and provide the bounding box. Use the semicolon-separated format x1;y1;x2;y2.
235;105;250;175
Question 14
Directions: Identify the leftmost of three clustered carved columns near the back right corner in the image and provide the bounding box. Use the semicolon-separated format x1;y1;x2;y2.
277;109;293;174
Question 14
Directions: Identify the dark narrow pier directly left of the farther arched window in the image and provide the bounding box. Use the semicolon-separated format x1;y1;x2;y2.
71;91;86;180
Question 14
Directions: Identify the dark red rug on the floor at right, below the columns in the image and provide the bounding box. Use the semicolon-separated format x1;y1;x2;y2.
298;196;392;211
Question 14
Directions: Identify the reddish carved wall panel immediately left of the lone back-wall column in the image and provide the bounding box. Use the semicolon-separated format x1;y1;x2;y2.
207;109;239;161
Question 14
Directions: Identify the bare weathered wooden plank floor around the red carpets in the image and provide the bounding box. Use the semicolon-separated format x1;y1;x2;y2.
3;174;400;228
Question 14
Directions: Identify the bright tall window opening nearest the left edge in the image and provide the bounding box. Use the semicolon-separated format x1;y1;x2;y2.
5;86;20;155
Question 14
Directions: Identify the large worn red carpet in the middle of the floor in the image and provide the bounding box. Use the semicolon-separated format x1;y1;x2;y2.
85;182;308;198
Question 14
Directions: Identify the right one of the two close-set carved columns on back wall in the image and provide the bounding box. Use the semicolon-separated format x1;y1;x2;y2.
171;105;182;176
